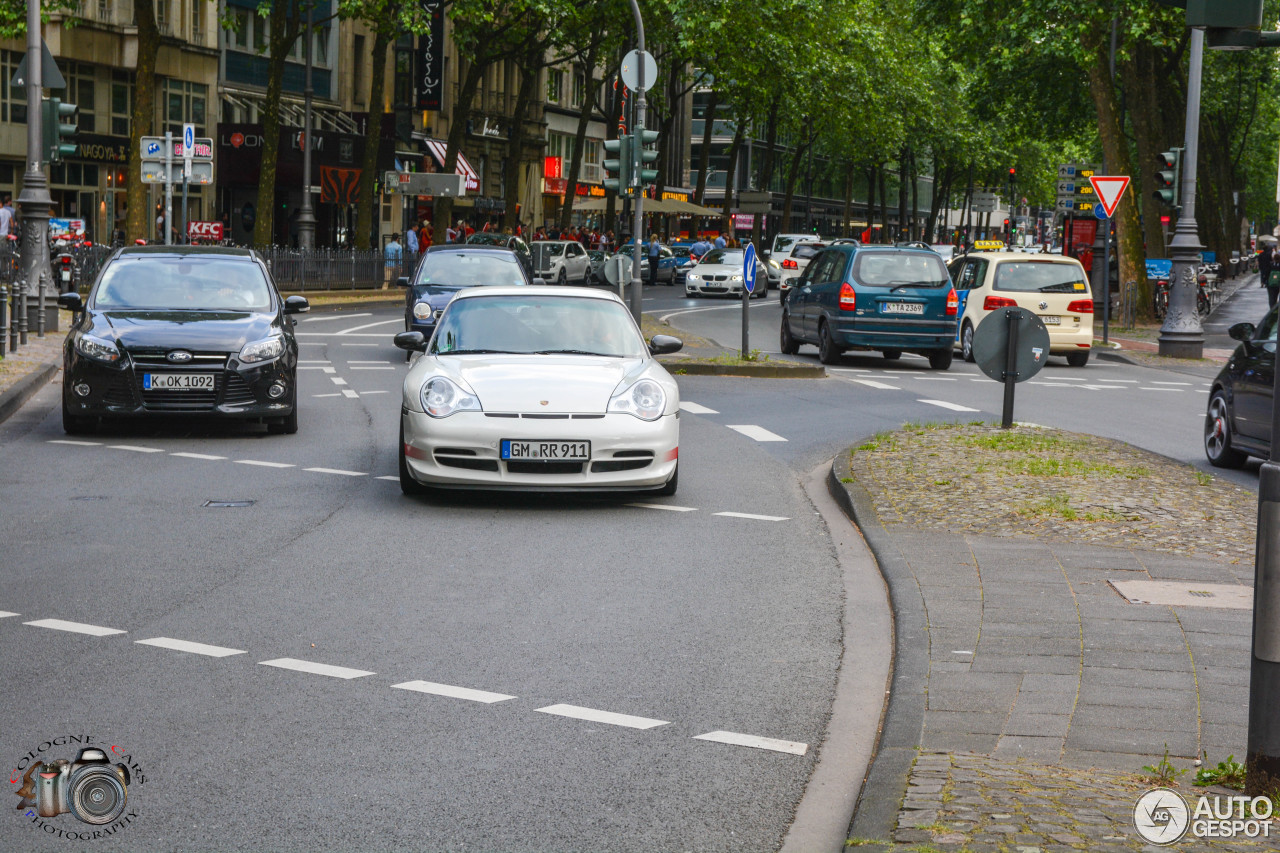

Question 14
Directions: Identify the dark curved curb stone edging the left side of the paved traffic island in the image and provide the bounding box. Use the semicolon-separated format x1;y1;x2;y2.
831;455;929;841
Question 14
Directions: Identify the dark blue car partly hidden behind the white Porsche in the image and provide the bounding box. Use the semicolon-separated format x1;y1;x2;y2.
398;243;545;338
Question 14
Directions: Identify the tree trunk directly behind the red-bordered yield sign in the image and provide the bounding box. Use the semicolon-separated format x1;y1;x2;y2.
1084;23;1152;320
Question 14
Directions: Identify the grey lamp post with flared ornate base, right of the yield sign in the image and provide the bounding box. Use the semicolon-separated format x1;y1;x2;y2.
1160;28;1204;359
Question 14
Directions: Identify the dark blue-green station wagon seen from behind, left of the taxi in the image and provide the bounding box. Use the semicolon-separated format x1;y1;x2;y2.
780;243;960;370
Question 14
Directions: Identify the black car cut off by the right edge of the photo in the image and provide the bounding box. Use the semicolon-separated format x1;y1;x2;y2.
1204;309;1277;467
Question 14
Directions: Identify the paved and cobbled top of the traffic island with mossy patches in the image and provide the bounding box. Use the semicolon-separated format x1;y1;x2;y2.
831;421;1280;850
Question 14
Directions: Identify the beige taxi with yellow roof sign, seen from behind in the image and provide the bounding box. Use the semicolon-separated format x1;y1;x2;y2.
947;252;1093;368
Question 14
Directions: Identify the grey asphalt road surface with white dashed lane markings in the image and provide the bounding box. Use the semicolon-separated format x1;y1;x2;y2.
0;288;1256;850
